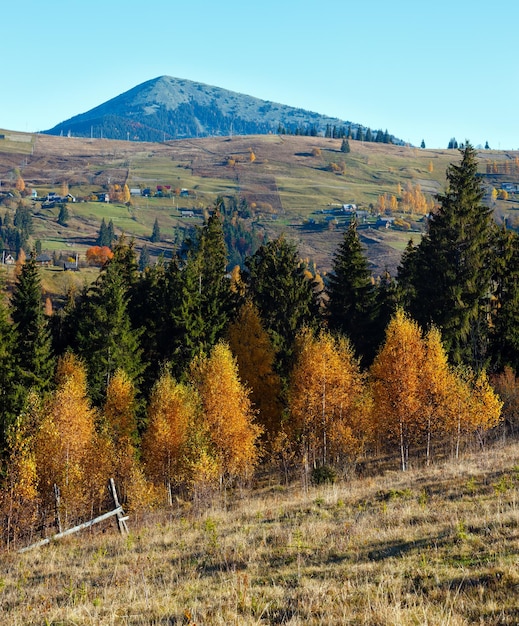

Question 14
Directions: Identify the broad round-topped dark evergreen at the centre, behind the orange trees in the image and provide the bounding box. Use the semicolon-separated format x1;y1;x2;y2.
245;236;320;376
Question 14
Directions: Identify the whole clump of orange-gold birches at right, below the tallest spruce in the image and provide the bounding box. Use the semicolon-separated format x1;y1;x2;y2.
370;310;502;470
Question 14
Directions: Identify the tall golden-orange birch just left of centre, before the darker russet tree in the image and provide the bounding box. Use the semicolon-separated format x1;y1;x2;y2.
191;341;261;486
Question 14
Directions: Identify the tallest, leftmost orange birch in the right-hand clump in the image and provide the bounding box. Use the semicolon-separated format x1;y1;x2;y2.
370;309;425;471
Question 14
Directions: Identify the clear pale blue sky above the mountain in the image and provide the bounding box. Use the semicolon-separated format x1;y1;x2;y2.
0;0;519;149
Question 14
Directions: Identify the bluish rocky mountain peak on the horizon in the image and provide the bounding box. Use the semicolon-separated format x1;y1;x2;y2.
44;76;400;143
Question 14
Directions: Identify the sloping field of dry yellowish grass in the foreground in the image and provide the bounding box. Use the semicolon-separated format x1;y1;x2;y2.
0;443;519;626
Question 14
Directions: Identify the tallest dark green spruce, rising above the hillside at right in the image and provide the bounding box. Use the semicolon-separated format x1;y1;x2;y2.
410;143;494;369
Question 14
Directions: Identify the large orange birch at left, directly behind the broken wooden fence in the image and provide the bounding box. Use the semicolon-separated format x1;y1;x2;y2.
34;353;112;521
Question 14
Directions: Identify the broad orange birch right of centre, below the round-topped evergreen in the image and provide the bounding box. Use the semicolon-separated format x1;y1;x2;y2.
288;330;369;471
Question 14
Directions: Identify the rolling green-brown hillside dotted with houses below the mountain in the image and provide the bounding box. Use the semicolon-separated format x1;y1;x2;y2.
0;131;519;280
